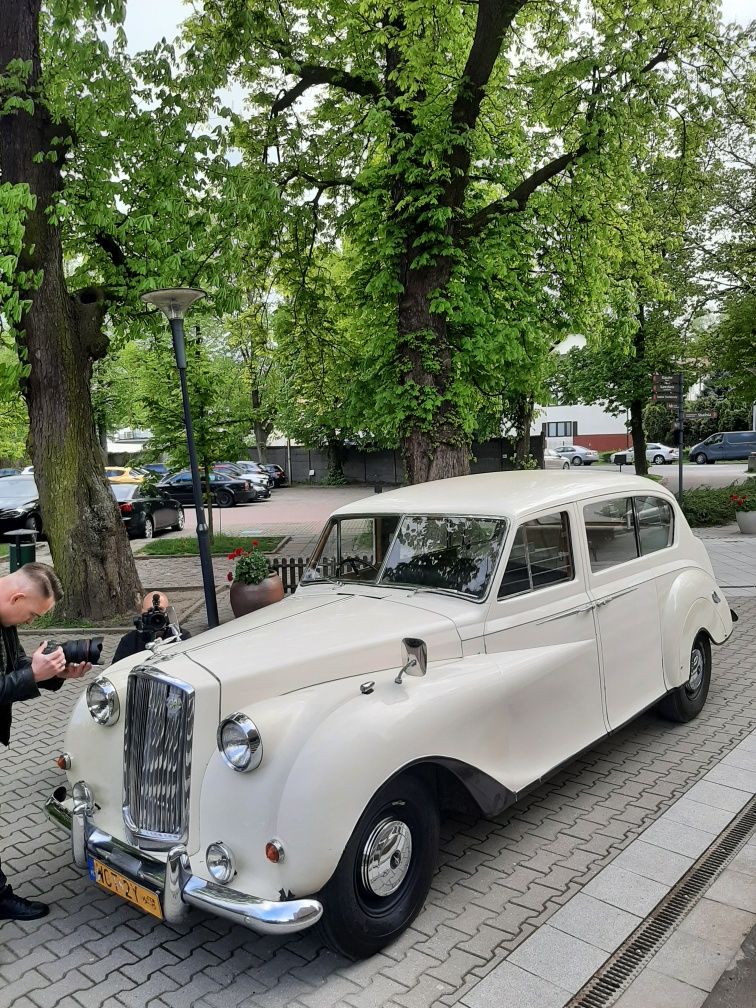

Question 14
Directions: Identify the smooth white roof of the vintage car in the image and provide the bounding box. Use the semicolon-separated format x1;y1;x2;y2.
334;467;674;518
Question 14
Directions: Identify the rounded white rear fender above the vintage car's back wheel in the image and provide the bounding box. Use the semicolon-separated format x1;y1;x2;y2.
661;570;732;689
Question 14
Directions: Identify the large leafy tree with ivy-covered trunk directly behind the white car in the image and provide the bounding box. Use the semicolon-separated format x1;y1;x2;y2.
191;0;745;482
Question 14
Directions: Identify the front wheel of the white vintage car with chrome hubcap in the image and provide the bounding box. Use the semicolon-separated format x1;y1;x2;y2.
319;774;438;959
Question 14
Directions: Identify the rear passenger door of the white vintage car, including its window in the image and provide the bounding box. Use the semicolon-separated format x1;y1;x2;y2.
583;495;665;729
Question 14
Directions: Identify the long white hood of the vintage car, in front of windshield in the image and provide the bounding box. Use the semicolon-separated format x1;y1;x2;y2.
172;592;462;713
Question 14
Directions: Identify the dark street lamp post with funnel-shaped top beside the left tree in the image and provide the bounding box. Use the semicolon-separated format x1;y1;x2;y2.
141;287;218;627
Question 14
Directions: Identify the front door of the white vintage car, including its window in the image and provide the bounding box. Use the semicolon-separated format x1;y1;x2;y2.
485;506;606;791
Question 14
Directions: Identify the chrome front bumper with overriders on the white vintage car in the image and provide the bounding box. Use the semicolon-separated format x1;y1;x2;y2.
44;781;323;934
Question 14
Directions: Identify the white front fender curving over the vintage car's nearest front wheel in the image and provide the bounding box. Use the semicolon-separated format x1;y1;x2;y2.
193;648;554;898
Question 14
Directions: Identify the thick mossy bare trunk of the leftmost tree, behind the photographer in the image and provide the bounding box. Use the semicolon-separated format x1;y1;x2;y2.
0;0;142;620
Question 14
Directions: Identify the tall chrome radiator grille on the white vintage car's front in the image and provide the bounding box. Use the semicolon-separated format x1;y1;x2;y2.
123;667;195;850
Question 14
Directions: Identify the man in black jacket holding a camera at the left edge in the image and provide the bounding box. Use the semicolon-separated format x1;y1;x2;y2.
0;563;92;920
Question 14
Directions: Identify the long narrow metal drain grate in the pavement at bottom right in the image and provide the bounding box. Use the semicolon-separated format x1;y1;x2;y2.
566;798;756;1008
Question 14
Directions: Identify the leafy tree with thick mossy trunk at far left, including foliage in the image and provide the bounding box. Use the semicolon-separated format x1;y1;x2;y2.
0;0;268;618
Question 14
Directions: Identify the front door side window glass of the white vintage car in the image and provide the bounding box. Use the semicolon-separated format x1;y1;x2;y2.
498;511;575;599
